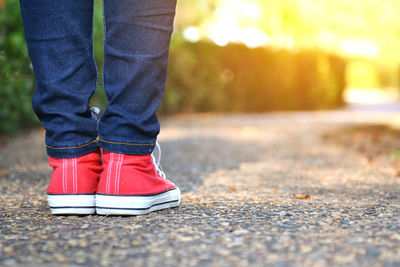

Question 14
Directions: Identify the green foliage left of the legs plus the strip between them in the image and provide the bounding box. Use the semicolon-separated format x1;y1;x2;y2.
0;0;107;134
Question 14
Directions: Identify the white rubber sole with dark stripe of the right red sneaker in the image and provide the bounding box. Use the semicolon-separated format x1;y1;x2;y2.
96;188;181;215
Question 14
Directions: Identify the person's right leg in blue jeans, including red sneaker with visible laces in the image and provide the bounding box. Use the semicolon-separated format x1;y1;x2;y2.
96;0;180;215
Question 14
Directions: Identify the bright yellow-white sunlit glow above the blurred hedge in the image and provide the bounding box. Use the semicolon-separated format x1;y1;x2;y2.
177;0;400;102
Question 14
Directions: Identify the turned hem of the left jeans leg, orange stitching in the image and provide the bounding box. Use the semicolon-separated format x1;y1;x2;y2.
46;139;98;158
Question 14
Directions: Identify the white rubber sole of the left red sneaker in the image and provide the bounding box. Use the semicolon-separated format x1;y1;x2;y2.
47;194;96;215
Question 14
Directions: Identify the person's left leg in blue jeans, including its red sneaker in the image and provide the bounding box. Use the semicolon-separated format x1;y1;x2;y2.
21;0;101;214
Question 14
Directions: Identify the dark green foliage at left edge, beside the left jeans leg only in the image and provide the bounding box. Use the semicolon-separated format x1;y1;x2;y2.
0;0;38;134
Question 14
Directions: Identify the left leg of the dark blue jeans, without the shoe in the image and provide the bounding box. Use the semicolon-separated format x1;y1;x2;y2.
20;0;97;158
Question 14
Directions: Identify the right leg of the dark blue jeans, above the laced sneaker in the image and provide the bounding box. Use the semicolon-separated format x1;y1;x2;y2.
98;0;176;154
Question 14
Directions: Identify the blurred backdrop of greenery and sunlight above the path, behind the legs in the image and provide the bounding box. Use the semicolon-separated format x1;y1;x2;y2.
0;0;400;134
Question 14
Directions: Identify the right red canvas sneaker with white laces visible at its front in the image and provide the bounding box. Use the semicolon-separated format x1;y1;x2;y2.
96;144;181;215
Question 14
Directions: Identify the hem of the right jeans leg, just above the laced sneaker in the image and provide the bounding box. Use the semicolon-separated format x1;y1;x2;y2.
97;138;155;155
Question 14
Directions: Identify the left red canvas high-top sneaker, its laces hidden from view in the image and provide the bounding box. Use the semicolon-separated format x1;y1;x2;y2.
47;149;102;214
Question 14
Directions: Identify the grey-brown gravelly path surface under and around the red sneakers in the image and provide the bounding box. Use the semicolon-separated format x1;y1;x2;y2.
0;111;400;266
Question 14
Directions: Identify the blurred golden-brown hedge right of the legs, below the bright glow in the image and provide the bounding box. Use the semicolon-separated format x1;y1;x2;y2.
161;42;345;113
